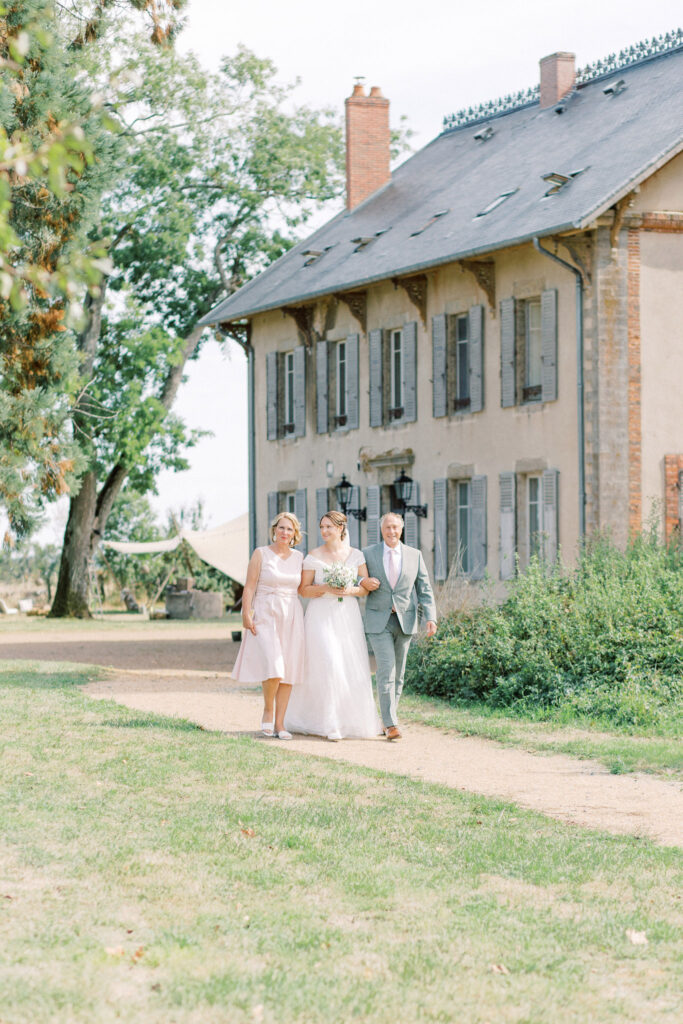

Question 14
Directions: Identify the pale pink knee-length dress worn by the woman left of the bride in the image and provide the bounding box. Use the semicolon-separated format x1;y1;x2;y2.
232;548;304;684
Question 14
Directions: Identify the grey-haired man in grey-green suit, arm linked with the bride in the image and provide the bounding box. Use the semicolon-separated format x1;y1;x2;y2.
361;512;436;739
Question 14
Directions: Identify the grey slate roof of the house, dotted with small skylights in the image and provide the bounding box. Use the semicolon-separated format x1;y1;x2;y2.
202;46;683;325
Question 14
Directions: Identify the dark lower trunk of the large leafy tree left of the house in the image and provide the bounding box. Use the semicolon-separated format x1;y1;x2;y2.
50;470;97;618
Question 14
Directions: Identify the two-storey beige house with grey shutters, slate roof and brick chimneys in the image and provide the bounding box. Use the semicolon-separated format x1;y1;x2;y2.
200;32;683;581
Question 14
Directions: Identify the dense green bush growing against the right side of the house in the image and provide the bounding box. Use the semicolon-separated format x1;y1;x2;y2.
405;534;683;731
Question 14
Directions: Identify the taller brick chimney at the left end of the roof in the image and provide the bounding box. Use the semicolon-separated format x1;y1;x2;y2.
346;83;391;210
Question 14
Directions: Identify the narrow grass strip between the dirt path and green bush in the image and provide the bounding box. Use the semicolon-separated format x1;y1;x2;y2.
400;693;683;779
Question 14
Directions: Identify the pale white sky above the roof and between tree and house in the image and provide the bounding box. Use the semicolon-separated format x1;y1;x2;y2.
29;0;683;541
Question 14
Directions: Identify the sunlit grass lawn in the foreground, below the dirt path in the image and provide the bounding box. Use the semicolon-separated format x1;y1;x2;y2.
0;663;683;1024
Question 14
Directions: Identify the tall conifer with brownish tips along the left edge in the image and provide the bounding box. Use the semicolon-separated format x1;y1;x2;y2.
0;0;184;535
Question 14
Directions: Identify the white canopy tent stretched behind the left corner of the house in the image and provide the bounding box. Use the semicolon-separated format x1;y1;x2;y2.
102;513;249;584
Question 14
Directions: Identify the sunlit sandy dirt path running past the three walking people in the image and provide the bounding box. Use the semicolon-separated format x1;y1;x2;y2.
85;670;683;846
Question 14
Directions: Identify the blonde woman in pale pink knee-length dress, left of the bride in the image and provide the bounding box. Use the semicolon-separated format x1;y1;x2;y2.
232;512;304;739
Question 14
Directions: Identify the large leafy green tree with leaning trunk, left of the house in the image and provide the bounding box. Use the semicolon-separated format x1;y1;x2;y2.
52;40;342;616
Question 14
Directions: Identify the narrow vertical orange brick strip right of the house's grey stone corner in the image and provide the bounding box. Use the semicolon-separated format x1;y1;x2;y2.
627;228;643;534
